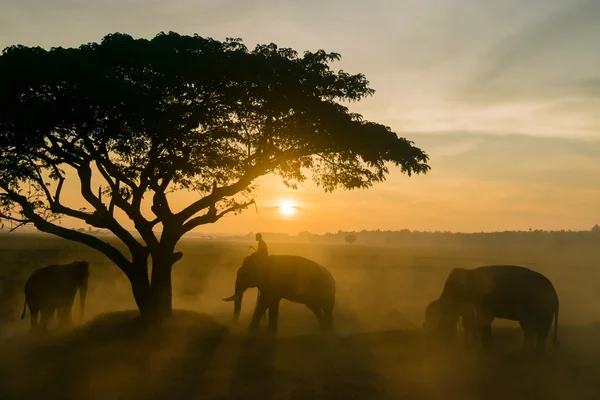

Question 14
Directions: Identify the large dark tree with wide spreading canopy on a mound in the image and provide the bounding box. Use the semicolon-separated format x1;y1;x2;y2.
0;32;429;317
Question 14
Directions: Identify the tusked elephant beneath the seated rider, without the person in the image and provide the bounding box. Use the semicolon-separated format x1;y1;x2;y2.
223;254;335;333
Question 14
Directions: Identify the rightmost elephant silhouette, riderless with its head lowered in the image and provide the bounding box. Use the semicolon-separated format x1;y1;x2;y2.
426;265;560;356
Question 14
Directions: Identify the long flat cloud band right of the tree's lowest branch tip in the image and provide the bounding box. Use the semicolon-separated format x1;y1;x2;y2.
413;133;600;191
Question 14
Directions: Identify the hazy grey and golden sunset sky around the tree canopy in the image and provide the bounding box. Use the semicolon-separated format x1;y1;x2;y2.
0;0;600;234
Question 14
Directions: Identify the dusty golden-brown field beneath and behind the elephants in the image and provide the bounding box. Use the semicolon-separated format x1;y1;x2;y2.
0;231;600;400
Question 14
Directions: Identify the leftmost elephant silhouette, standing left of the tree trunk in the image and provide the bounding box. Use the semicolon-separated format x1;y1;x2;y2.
21;261;90;331
